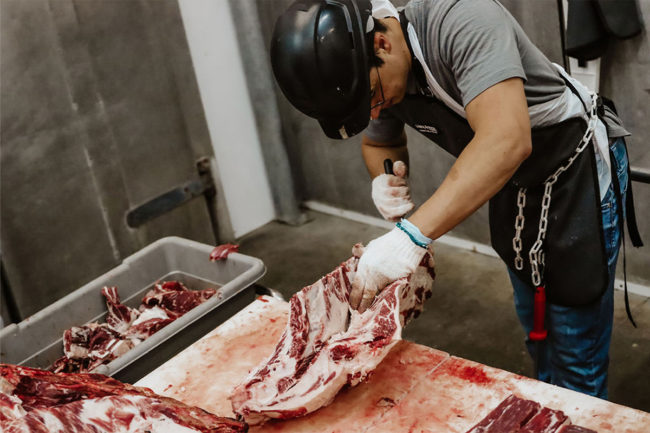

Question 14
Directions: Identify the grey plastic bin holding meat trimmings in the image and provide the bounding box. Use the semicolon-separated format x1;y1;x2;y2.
0;237;266;383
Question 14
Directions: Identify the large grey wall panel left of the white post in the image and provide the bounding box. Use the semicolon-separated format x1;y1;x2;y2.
0;0;215;317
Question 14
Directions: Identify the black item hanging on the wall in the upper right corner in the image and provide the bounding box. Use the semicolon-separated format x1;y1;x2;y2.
566;0;643;61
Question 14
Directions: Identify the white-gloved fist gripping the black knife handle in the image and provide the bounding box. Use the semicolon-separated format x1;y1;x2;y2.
372;161;415;222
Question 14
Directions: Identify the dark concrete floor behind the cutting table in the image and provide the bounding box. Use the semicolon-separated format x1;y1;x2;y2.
239;211;650;412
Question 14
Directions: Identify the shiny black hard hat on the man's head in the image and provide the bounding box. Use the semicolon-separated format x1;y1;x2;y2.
271;0;374;139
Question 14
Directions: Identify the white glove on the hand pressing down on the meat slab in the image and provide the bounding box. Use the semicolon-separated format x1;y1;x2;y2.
350;227;427;313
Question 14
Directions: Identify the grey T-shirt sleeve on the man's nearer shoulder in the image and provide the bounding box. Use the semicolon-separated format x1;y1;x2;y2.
440;0;526;107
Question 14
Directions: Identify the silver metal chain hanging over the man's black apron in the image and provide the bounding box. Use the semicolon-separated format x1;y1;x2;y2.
512;93;598;287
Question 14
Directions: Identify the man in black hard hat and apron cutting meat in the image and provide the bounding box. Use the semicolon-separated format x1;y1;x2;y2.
271;0;629;398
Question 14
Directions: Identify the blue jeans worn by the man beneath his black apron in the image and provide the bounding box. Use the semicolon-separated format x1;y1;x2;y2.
508;139;628;399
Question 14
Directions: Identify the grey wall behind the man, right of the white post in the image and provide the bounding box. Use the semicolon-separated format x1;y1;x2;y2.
249;0;650;284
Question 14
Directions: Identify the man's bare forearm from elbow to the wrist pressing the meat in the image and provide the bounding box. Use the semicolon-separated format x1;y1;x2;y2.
409;137;529;239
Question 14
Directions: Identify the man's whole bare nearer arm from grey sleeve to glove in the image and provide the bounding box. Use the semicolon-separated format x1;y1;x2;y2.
409;78;532;239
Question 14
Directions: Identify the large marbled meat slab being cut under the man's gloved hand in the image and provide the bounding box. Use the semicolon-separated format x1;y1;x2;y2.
231;246;434;424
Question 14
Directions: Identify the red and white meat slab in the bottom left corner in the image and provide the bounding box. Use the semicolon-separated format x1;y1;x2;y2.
0;364;248;433
